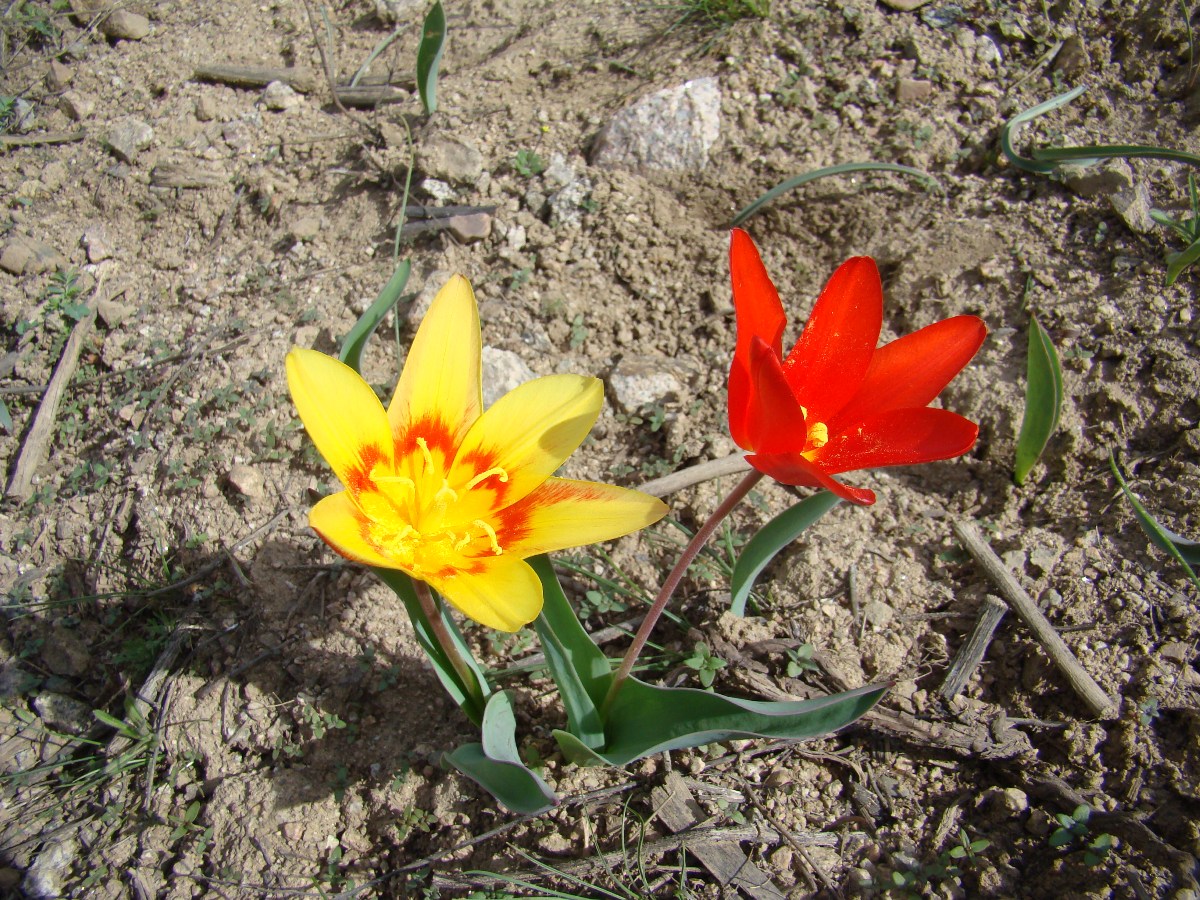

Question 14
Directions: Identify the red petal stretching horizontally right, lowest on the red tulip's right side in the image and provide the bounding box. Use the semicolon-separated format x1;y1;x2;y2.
816;407;979;475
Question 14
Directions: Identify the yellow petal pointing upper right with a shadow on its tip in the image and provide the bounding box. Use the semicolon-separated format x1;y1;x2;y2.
450;374;604;522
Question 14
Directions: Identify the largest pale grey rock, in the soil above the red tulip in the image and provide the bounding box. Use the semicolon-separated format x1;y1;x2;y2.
592;78;721;170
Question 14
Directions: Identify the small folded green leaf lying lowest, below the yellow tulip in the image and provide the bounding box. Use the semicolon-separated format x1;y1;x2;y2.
445;691;558;816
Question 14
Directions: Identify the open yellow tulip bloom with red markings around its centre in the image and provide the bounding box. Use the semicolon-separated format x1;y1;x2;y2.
287;276;666;631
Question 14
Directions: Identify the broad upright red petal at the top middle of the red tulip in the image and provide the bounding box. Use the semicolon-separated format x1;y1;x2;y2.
784;257;883;422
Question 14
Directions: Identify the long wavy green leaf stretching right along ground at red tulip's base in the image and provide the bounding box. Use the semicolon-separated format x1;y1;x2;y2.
554;678;888;766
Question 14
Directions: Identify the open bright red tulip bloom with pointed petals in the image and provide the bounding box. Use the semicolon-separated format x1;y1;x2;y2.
730;229;986;505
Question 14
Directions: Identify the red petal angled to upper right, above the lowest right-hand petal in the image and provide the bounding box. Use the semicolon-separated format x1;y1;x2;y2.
827;316;988;432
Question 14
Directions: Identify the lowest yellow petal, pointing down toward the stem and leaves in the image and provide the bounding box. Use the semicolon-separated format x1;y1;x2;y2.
430;553;541;631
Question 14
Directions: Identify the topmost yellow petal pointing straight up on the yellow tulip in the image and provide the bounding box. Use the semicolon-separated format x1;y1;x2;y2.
388;275;484;444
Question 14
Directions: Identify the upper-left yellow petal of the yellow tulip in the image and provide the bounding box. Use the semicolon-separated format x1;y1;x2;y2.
287;347;392;493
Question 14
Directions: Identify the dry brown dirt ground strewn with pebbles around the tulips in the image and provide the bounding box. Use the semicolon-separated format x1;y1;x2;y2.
0;0;1200;900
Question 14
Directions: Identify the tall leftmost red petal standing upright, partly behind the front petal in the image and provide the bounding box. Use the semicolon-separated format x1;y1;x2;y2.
730;228;787;446
